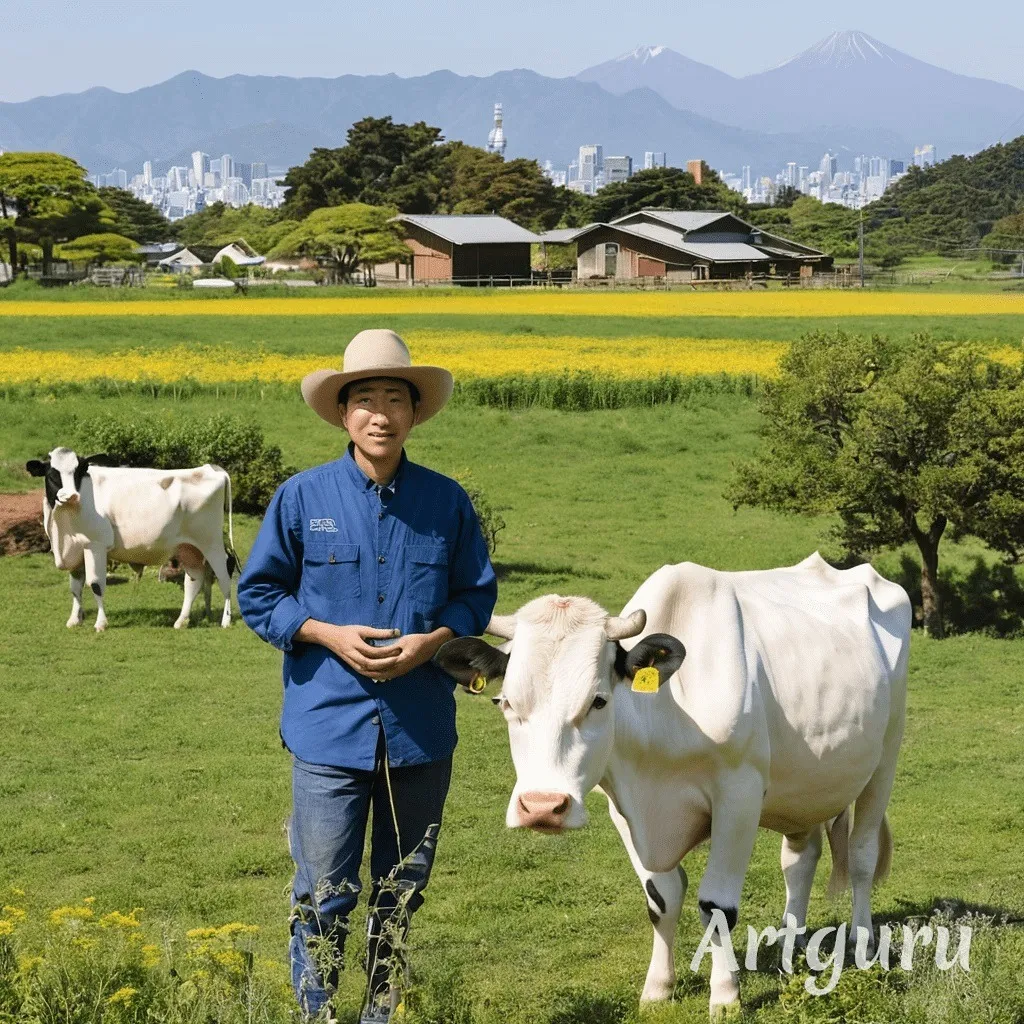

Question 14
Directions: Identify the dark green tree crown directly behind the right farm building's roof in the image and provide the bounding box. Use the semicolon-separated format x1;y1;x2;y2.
589;167;746;221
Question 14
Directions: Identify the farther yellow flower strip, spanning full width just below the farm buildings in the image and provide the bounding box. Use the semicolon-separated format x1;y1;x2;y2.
0;289;1024;317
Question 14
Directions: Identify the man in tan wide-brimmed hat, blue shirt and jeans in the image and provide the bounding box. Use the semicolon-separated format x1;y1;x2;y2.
239;331;497;1022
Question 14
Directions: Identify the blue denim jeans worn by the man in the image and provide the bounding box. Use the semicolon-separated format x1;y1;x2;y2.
288;734;452;1014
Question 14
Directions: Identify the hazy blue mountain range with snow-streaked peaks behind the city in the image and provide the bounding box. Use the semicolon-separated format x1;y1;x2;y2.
0;32;1024;174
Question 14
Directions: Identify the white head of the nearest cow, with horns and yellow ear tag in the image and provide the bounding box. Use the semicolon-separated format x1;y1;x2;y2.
436;595;686;833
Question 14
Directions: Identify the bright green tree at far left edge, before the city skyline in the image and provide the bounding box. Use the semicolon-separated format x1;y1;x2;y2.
0;153;115;273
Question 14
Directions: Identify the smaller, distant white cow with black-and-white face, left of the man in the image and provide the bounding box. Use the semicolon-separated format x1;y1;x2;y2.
25;447;234;632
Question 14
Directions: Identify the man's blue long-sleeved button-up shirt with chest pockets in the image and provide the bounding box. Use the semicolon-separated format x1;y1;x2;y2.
239;445;498;770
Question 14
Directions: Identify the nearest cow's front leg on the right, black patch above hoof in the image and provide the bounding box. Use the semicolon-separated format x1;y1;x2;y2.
697;770;764;1015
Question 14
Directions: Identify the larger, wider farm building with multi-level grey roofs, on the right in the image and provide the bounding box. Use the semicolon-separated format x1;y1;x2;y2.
541;209;833;281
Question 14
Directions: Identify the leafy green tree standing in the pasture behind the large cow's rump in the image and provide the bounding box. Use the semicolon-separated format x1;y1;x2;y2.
731;332;1024;636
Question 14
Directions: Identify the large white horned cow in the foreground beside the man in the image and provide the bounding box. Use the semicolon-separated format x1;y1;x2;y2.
437;553;911;1011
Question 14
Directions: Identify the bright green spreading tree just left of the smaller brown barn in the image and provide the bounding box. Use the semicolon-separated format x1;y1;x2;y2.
267;203;410;282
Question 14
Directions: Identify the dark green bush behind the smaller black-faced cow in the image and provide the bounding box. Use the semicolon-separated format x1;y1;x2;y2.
76;414;297;514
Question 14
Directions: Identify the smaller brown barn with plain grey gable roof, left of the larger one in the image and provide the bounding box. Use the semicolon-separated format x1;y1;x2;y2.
387;213;541;284
